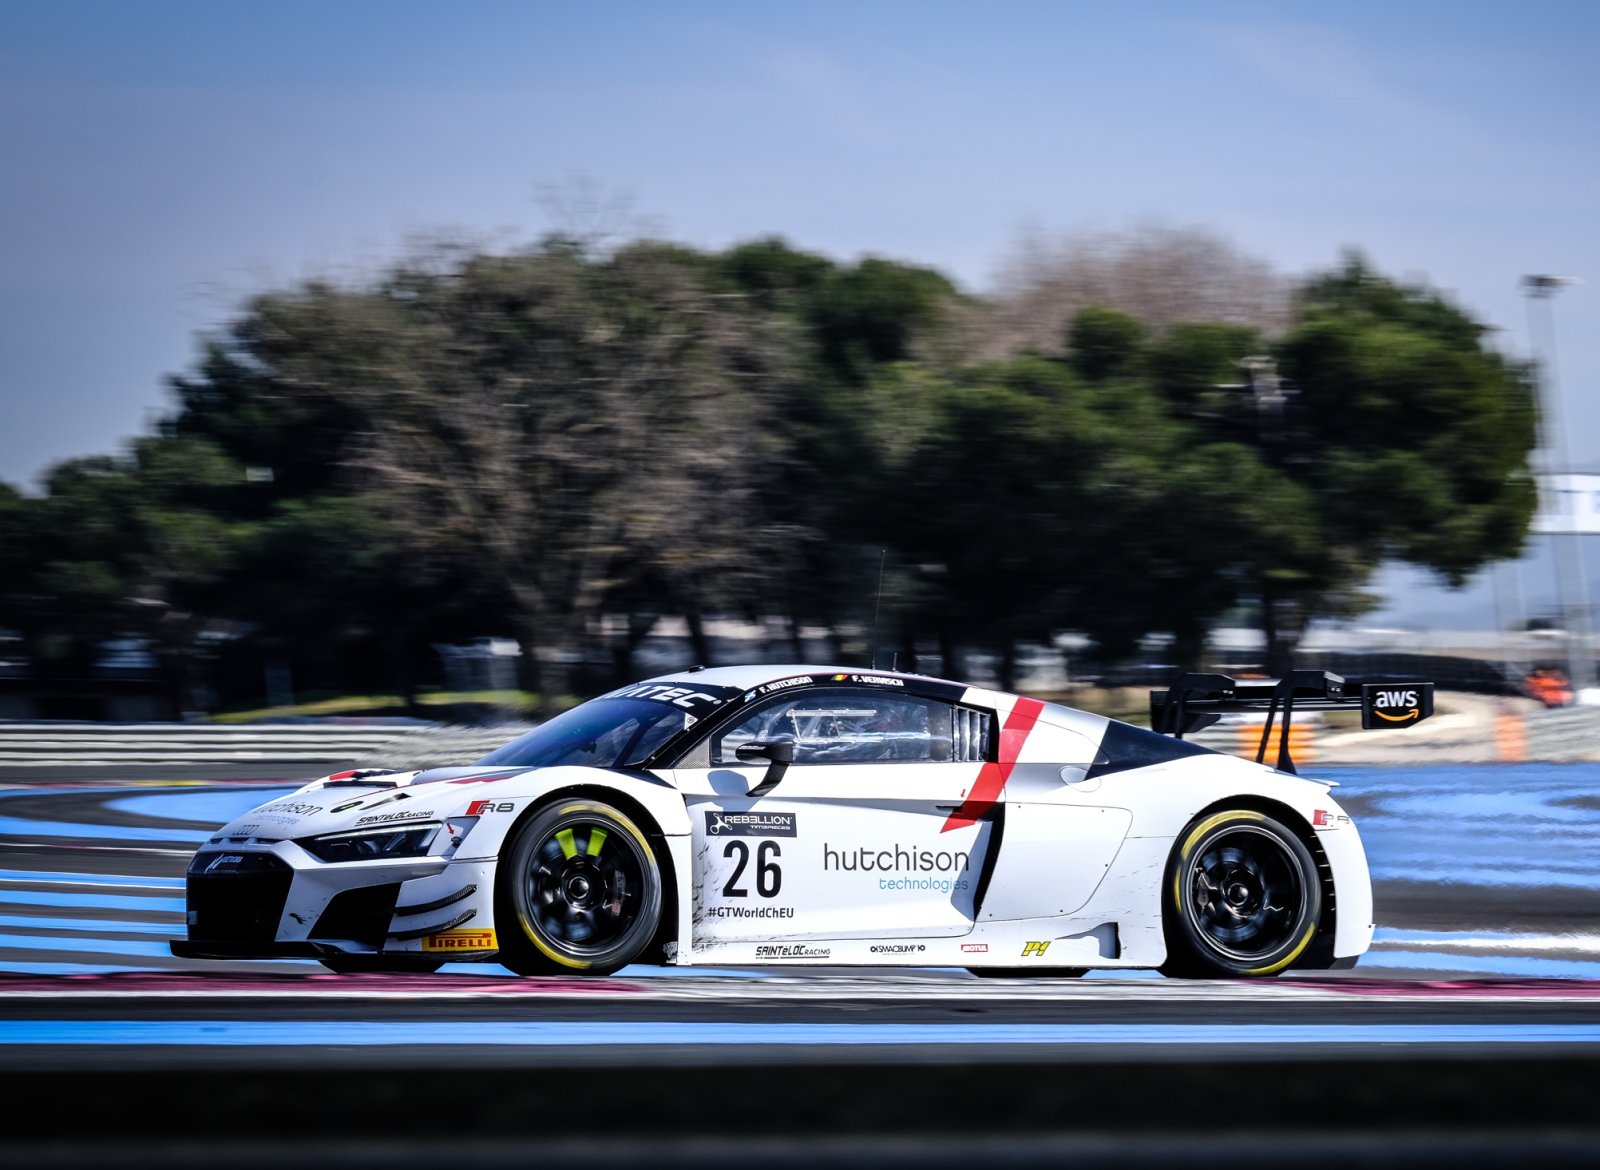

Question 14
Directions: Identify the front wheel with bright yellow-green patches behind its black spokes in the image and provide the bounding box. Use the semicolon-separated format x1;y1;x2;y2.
494;799;662;975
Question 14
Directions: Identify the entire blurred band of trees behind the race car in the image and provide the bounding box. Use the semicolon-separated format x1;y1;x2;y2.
0;237;1534;709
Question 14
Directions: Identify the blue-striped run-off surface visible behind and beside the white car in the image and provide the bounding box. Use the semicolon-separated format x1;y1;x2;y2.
0;763;1600;978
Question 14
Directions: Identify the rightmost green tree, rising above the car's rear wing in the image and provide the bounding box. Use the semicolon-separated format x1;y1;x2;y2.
1251;256;1536;669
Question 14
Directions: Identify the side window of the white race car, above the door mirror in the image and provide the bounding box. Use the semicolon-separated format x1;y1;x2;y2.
710;688;990;765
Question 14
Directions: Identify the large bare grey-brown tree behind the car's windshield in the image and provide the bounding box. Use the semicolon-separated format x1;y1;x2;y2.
240;240;812;699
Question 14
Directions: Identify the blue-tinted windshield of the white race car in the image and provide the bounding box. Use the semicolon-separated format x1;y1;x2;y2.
478;699;694;768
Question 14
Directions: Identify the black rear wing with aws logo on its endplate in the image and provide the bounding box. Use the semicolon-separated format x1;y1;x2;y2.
1150;671;1434;773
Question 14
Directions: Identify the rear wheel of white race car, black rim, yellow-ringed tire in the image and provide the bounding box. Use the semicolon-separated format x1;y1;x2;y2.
1162;808;1322;978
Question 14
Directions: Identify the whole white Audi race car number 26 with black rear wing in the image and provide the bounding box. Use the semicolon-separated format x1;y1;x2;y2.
171;666;1432;976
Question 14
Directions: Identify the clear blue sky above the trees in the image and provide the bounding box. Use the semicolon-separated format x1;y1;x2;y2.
0;0;1600;630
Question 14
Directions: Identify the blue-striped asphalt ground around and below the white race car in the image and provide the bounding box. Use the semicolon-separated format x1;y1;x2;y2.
9;765;1600;1167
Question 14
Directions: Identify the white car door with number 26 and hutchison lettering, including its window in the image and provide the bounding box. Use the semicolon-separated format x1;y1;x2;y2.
674;680;994;944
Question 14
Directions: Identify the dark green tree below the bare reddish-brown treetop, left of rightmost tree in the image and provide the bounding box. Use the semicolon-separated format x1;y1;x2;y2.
883;339;1266;687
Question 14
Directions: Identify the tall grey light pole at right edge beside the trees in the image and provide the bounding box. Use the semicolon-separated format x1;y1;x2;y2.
1522;275;1595;698
